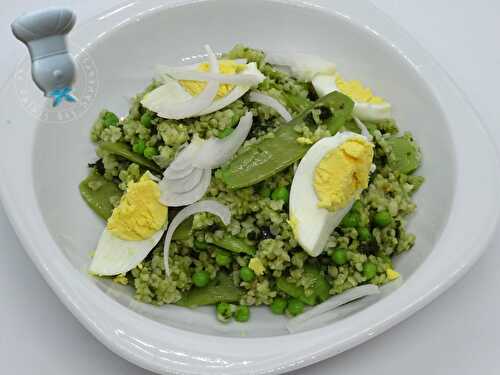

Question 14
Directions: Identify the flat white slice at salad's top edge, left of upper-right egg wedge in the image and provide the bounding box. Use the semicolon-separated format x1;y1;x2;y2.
266;52;336;81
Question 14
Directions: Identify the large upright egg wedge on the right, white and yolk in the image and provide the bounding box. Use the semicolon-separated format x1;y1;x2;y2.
289;132;373;257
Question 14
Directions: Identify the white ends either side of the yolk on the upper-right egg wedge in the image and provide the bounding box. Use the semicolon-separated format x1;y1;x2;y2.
311;74;392;121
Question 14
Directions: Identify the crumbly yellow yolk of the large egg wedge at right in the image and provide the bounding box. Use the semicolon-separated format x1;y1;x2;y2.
314;138;373;211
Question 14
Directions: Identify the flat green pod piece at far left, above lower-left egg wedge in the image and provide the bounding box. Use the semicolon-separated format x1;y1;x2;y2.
79;170;123;220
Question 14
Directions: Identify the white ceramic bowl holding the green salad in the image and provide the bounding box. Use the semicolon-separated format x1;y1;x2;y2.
0;0;500;374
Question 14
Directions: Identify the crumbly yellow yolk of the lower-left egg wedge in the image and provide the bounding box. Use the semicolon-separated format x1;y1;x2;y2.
108;175;168;241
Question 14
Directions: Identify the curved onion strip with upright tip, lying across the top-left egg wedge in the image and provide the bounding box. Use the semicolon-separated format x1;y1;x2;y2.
150;45;219;120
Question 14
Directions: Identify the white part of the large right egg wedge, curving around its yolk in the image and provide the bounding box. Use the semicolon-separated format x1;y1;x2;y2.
289;132;367;257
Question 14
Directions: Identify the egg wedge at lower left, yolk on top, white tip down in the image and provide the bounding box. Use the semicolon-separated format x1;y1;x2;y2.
89;173;168;276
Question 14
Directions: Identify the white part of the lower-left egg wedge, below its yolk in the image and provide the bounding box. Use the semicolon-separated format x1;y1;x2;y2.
89;228;165;276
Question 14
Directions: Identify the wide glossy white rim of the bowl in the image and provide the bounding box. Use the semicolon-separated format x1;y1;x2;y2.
0;0;500;374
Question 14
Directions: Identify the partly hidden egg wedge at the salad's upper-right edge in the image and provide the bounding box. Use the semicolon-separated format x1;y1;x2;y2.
311;73;392;121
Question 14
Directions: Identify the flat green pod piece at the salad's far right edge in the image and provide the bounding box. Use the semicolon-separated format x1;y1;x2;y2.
387;135;421;174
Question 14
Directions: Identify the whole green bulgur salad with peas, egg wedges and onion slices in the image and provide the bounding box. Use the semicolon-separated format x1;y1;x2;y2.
80;45;424;330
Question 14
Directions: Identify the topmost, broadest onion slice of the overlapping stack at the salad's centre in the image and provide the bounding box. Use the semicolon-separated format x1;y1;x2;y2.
193;112;253;169
